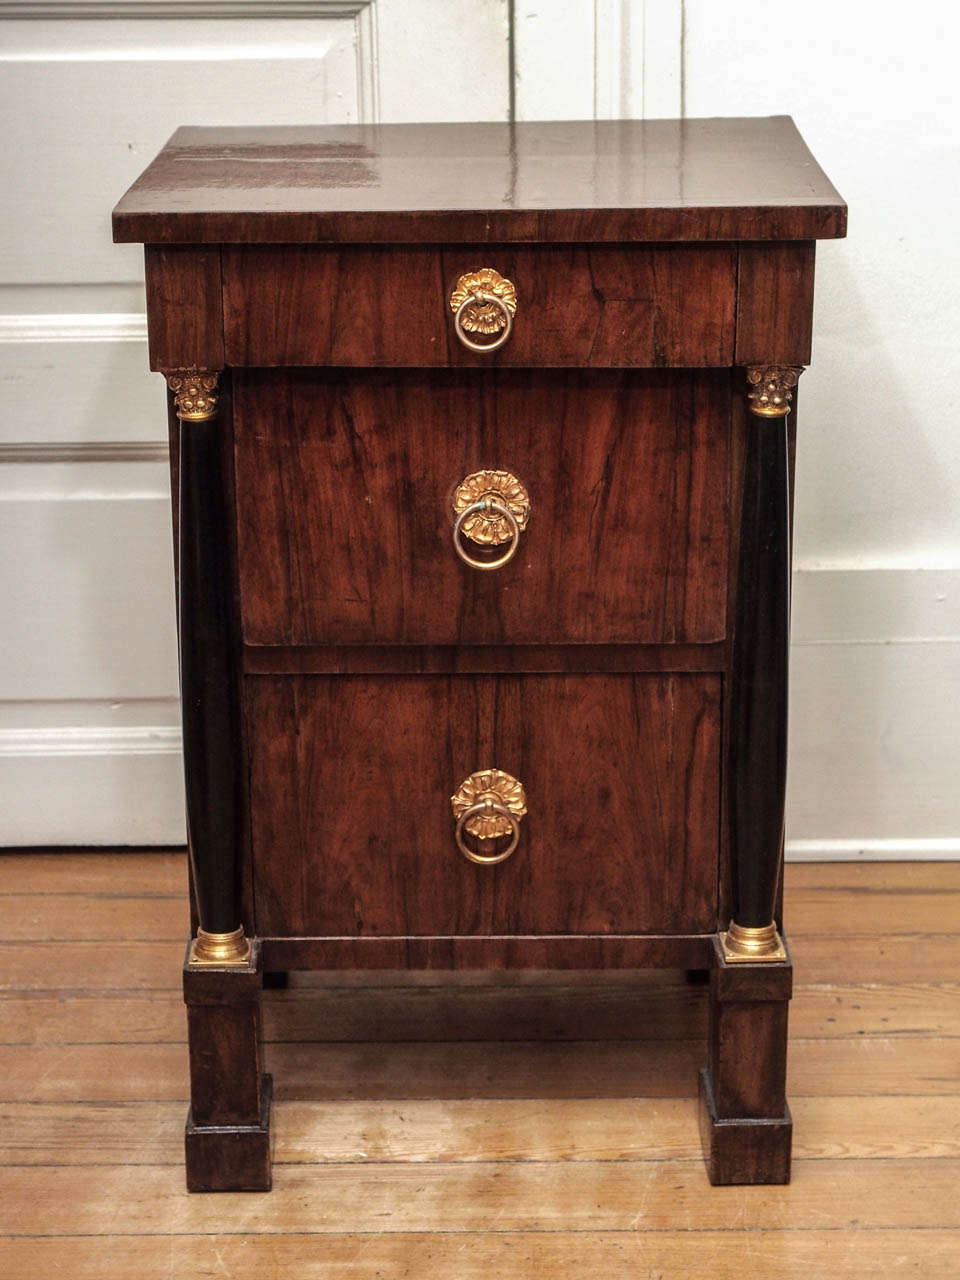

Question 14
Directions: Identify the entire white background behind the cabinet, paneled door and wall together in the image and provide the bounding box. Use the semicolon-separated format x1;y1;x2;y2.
0;0;960;856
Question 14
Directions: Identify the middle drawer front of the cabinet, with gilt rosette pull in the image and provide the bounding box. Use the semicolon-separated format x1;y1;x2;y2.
233;369;731;645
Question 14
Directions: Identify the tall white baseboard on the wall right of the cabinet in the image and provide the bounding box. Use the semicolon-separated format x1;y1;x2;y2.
787;567;960;860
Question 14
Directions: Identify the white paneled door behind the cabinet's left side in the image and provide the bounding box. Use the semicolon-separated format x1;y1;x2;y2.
0;0;511;846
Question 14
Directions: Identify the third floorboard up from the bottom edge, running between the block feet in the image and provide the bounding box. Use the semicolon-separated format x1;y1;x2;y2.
7;1095;960;1166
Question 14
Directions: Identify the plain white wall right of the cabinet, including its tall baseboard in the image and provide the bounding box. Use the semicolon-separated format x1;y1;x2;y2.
684;0;960;856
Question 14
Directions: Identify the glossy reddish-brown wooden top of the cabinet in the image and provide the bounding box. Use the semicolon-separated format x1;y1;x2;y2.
114;115;846;243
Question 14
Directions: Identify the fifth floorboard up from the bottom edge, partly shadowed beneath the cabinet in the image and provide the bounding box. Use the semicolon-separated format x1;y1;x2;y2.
4;977;960;1049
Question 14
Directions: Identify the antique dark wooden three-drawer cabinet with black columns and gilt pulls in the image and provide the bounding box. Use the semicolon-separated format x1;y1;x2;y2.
114;118;846;1190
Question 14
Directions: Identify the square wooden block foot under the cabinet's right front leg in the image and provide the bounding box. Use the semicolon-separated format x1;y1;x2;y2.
700;1069;794;1187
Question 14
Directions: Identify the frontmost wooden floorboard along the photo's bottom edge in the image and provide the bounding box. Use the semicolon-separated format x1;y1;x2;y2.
0;1226;957;1280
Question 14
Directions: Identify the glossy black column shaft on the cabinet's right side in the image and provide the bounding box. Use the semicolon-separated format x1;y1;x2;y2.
727;413;790;927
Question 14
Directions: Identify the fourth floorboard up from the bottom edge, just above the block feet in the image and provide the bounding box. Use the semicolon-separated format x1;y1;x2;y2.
0;1034;957;1105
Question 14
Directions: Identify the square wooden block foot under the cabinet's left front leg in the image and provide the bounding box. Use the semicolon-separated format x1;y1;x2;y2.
186;1075;273;1192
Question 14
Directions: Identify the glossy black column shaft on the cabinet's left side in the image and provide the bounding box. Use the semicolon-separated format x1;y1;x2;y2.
178;394;239;933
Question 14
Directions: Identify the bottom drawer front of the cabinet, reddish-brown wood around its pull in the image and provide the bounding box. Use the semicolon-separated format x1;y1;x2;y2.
246;675;721;937
